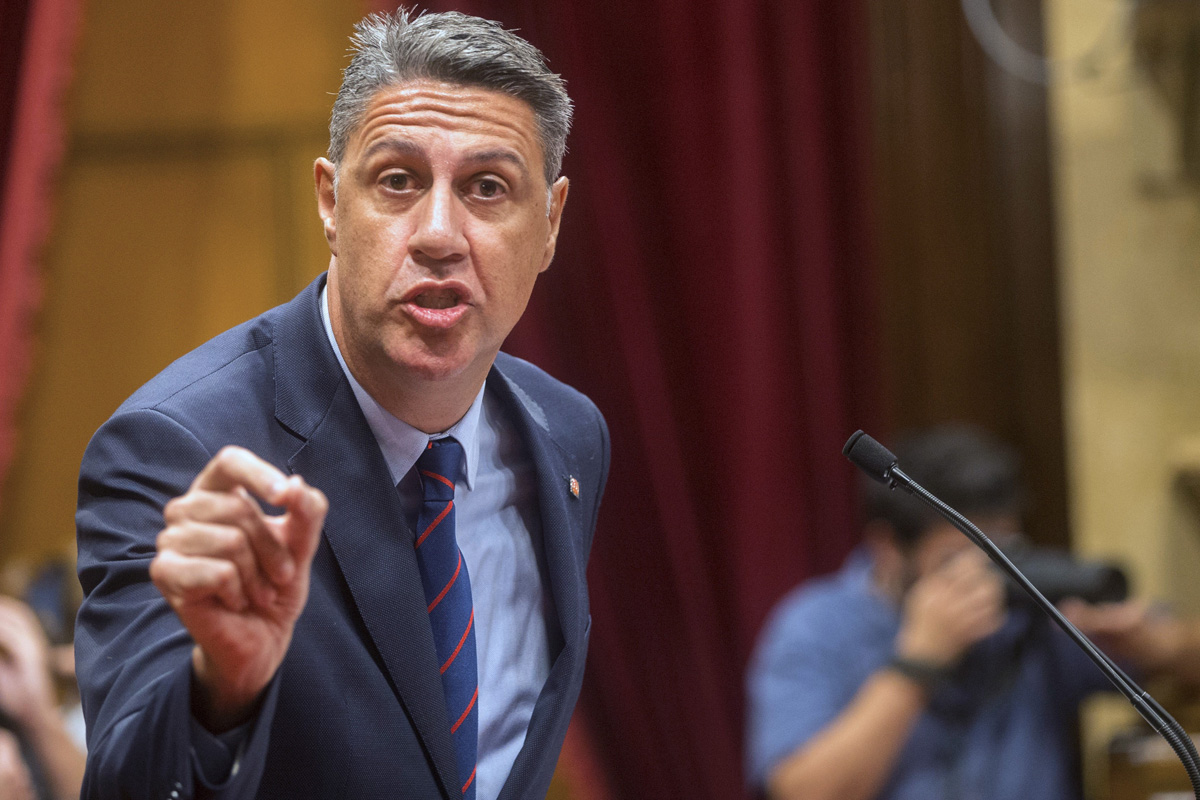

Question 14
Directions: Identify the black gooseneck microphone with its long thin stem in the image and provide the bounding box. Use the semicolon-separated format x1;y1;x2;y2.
841;431;1200;800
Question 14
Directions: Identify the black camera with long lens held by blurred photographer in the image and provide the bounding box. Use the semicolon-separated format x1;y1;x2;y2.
1002;542;1129;604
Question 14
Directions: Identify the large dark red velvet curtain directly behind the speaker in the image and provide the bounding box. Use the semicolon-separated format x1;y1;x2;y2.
379;0;880;800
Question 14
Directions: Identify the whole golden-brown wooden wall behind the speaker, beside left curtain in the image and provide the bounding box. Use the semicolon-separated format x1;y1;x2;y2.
0;0;362;563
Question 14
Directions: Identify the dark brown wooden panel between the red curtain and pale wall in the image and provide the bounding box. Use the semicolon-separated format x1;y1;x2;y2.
871;0;1069;545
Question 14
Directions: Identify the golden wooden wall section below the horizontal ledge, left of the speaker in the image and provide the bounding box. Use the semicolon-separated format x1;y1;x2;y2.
4;154;276;557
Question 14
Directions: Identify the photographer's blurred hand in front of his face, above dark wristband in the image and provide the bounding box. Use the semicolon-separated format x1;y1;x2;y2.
896;551;1006;667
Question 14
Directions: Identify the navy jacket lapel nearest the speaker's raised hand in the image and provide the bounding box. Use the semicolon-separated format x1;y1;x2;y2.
275;283;460;796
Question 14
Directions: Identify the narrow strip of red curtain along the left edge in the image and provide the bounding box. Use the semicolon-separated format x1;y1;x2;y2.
0;0;80;506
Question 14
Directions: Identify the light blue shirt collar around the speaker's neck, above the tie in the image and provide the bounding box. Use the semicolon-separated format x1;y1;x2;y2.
320;283;484;489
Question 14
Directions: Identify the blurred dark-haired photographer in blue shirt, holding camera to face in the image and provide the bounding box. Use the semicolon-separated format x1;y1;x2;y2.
746;426;1200;800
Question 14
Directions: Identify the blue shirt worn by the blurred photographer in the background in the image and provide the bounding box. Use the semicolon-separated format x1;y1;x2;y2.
746;551;1110;800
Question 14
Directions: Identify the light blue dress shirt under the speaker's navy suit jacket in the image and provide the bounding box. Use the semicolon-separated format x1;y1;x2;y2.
320;289;560;800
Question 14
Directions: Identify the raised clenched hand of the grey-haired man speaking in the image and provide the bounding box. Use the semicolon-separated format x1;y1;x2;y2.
150;446;329;730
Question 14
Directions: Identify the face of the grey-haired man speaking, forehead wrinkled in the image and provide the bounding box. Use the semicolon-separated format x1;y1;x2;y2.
316;80;566;405
